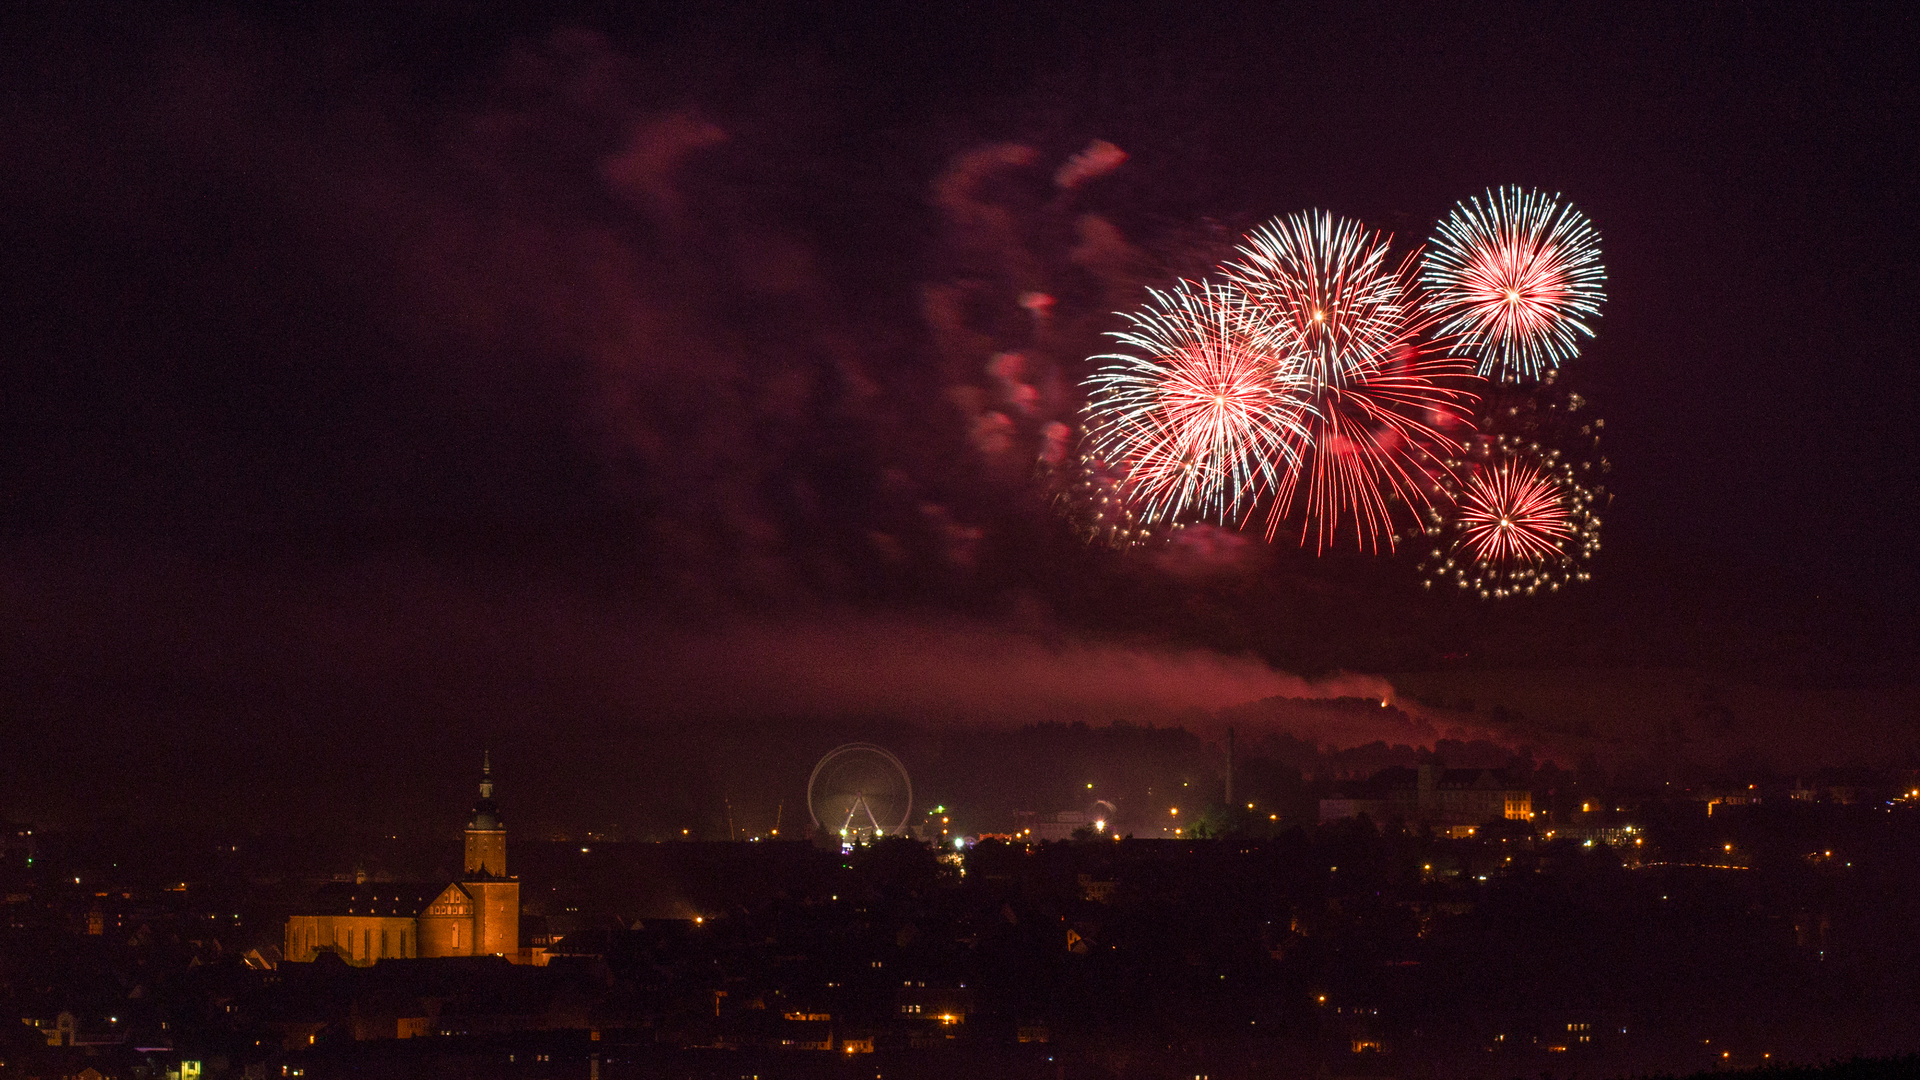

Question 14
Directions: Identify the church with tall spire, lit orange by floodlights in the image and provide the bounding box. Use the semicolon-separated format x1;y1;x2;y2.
284;763;530;965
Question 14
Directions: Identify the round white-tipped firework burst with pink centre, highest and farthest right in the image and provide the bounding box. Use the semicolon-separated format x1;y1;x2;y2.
1421;186;1607;379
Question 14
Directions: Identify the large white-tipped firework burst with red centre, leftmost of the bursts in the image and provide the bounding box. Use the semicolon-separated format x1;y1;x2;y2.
1089;282;1308;521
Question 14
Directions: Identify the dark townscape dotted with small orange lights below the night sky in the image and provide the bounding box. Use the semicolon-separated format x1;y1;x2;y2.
0;760;1920;1080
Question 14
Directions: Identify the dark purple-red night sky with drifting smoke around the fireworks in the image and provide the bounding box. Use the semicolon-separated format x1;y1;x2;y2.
0;4;1920;824
